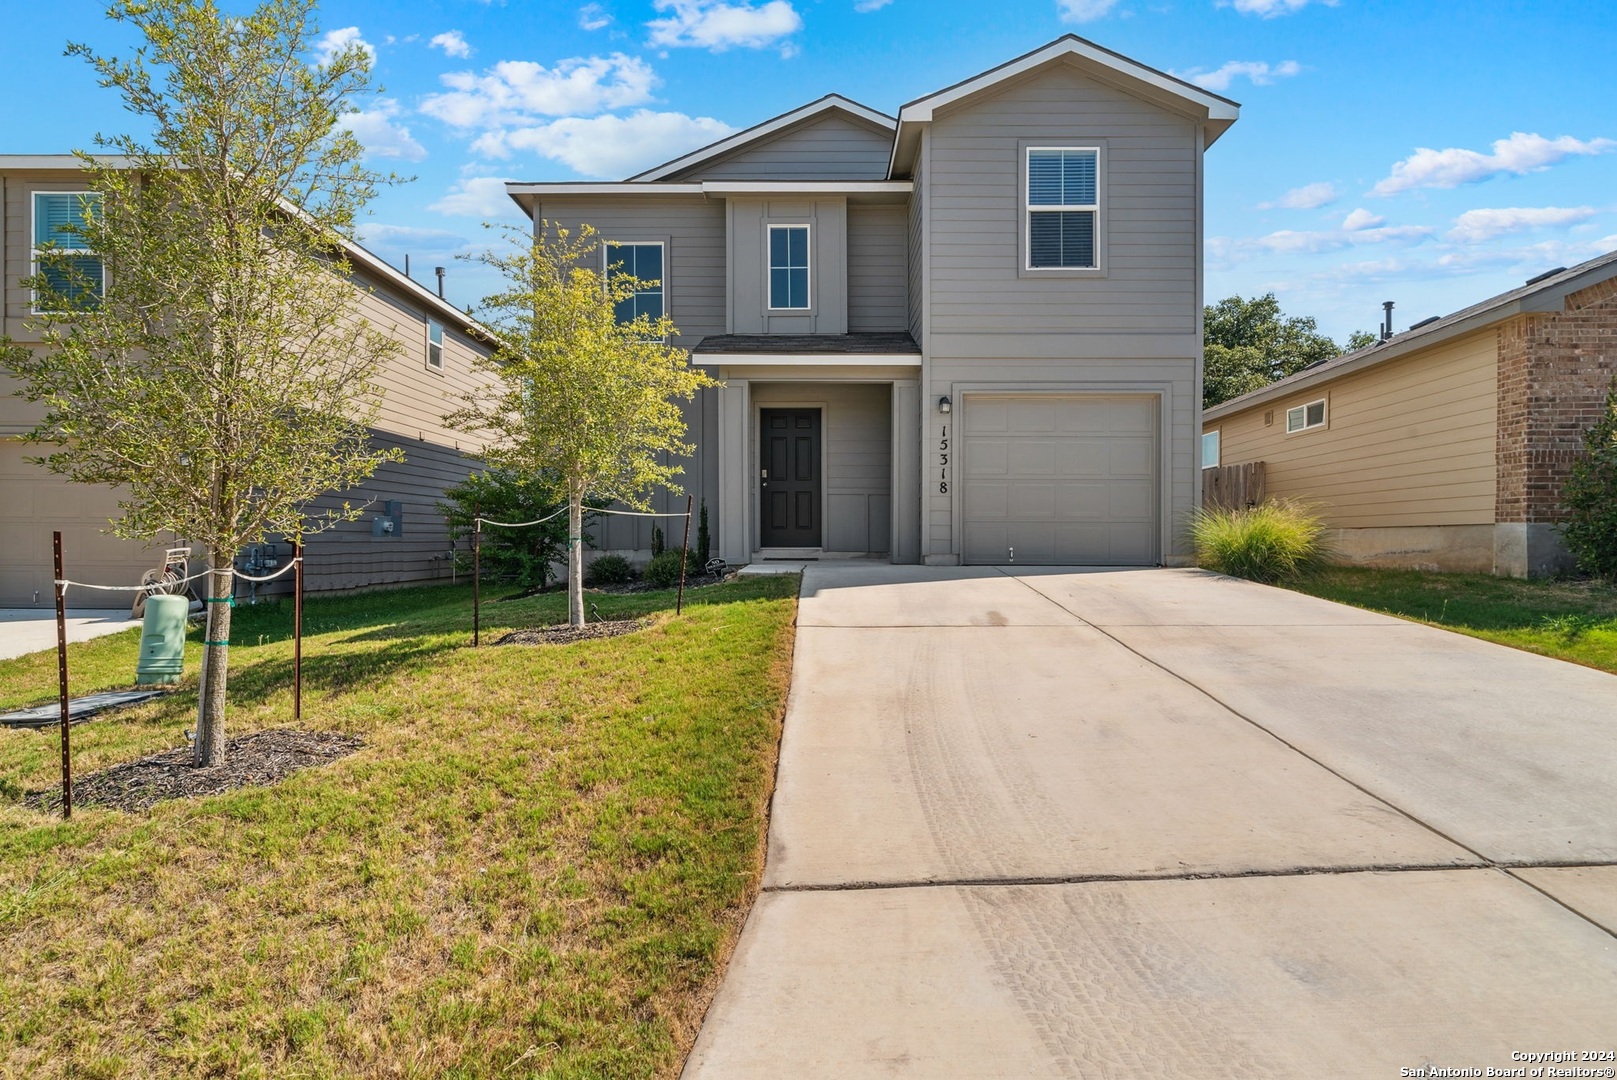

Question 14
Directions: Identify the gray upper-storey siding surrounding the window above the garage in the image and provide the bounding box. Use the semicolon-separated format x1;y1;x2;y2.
927;65;1198;335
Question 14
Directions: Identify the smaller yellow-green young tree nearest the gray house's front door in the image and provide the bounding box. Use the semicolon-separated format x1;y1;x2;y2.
445;223;718;626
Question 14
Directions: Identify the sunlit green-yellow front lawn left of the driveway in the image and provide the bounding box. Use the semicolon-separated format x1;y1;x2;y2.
0;577;797;1078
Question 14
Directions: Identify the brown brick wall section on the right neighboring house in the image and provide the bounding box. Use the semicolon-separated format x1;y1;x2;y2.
1494;278;1617;522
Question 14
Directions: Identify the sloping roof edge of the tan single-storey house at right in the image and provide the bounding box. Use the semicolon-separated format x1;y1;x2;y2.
1201;251;1617;420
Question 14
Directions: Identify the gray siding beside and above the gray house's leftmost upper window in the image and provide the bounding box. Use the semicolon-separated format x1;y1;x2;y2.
534;196;726;349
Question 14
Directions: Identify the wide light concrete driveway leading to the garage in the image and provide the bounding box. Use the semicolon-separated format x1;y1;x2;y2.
686;566;1617;1080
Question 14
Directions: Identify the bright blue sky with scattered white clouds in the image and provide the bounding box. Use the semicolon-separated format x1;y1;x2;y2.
9;0;1617;340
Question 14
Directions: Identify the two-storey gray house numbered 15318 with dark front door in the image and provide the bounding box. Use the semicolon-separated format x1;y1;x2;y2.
509;36;1239;566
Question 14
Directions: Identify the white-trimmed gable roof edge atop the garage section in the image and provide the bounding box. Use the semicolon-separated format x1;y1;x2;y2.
888;34;1240;176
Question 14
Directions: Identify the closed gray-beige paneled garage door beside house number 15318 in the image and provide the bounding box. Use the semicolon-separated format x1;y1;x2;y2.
960;394;1159;566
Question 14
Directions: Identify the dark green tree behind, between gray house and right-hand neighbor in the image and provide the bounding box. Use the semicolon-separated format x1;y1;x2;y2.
1201;293;1342;407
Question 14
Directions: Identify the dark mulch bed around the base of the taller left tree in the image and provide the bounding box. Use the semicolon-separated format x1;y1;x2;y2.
23;728;364;810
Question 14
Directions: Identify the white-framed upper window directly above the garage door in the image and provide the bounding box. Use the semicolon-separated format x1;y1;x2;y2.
1025;147;1101;270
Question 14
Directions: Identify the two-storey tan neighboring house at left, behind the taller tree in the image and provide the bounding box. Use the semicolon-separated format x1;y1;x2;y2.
0;155;490;608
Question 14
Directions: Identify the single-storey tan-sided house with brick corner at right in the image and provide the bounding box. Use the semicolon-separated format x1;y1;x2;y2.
1201;252;1617;577
